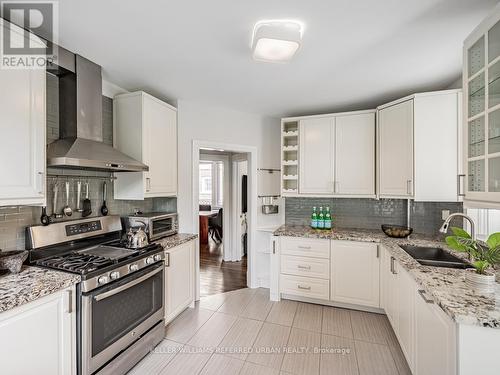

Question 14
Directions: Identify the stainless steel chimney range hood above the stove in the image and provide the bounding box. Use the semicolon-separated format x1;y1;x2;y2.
47;47;149;172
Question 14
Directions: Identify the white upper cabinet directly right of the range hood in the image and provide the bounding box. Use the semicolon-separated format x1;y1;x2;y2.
113;91;177;200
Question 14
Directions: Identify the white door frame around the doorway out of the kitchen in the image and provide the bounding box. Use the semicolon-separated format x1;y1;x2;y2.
191;140;258;301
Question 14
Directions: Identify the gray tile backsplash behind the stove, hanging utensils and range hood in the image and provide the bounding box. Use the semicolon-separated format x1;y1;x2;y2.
0;75;177;250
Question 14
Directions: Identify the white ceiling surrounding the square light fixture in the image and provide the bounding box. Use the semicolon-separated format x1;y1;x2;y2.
59;0;497;116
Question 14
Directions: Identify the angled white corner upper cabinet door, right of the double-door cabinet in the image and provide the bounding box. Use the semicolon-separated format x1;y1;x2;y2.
378;100;413;197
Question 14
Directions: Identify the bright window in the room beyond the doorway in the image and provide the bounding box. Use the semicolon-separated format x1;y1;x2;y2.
199;161;224;209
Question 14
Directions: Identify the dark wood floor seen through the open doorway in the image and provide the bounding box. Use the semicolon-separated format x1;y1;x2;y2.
200;238;247;297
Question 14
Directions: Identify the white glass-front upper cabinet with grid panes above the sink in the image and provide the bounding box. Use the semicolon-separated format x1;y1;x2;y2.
463;7;500;203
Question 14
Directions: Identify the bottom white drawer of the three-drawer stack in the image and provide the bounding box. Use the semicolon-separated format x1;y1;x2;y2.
280;274;330;300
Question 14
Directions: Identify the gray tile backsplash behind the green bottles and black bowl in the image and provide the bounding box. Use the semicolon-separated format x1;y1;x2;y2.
285;198;463;235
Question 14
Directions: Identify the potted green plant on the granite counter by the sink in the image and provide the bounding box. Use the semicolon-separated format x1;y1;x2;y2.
445;227;500;293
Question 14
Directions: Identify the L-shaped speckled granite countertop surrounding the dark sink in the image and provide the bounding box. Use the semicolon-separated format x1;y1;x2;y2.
274;225;500;329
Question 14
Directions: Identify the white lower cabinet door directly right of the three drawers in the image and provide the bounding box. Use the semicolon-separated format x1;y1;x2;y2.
330;241;380;307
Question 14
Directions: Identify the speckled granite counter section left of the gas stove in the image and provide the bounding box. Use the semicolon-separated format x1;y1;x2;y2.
0;266;80;313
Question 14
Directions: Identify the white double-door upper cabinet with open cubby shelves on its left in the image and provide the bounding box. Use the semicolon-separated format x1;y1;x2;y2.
290;110;375;197
